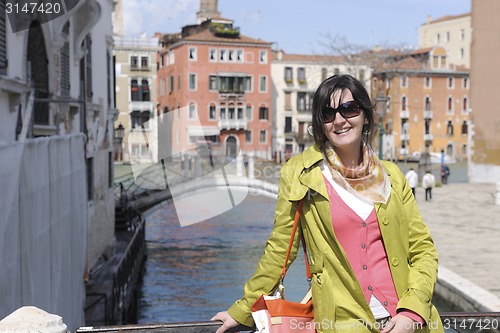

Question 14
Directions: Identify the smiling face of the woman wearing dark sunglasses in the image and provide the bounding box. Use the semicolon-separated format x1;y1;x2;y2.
323;89;365;151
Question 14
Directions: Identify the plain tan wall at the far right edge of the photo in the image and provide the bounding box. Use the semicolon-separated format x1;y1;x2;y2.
468;0;500;183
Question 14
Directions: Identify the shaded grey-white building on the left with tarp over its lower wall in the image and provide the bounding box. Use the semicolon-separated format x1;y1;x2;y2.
0;0;116;331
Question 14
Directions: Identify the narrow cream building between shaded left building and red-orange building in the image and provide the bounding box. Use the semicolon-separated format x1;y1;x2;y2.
113;36;158;163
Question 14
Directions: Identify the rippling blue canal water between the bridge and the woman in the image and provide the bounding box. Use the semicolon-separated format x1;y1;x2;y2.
139;195;307;324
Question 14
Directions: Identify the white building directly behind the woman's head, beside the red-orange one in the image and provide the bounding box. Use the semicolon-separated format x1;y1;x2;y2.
271;50;371;162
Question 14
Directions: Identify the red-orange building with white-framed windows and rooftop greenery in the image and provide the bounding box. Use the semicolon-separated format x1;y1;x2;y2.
157;15;272;158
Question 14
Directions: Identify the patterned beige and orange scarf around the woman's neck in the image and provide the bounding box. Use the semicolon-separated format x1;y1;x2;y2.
325;142;391;203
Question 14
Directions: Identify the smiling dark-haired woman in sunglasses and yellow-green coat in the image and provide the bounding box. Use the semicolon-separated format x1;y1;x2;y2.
212;75;443;333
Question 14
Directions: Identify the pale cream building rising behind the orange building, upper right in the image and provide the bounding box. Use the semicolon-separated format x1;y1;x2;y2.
418;13;472;68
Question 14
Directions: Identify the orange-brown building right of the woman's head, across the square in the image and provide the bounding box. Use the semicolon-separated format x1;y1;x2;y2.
372;47;470;160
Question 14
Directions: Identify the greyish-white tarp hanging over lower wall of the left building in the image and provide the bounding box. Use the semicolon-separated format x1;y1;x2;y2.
0;134;87;331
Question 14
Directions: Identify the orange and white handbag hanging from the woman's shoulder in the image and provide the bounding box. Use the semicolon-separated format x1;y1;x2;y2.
252;199;316;333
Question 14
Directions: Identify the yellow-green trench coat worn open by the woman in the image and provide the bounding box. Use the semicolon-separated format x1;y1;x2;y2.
228;145;443;333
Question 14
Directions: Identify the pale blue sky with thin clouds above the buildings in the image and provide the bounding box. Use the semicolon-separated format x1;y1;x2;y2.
123;0;472;54
